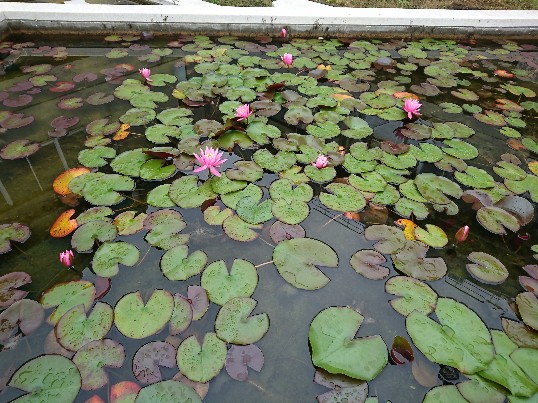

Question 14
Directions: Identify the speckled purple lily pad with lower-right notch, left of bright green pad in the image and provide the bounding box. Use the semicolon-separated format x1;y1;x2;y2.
133;341;176;384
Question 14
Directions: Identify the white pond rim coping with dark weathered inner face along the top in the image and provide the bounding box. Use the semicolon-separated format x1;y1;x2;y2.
0;0;538;39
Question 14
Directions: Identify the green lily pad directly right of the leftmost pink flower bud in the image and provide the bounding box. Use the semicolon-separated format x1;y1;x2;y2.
92;242;140;277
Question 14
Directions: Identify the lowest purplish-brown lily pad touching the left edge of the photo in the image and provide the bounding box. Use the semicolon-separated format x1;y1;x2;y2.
0;299;45;342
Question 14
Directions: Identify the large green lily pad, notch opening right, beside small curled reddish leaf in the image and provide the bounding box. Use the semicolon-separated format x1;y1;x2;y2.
308;307;388;381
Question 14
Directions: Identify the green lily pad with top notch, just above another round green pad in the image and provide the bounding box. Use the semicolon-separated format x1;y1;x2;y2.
201;259;258;306
